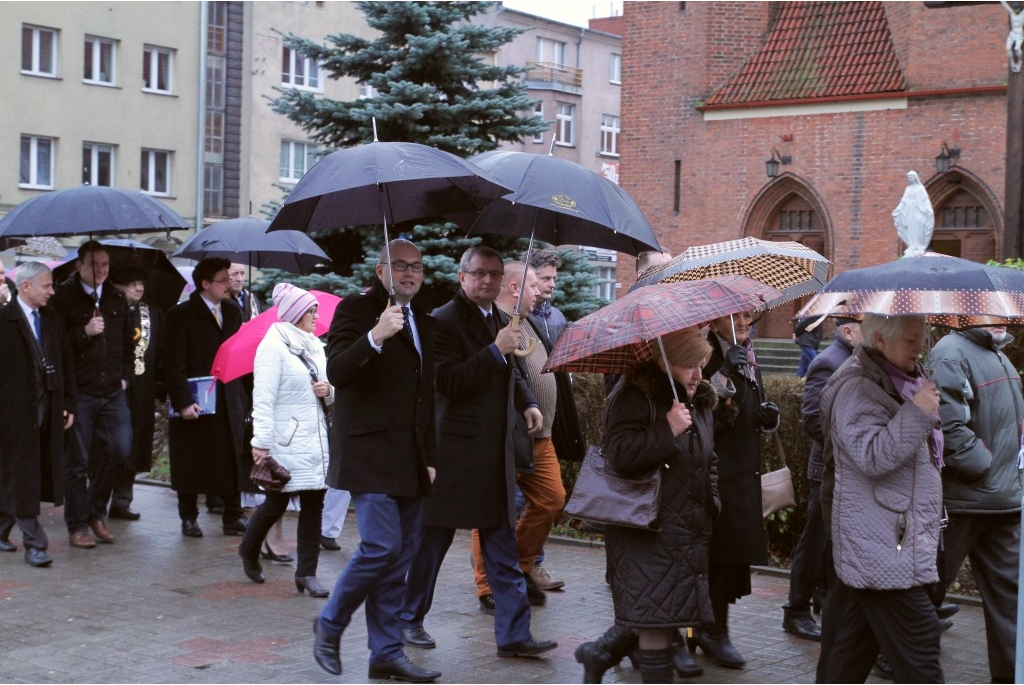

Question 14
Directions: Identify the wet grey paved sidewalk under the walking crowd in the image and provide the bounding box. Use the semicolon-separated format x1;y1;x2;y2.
0;485;988;683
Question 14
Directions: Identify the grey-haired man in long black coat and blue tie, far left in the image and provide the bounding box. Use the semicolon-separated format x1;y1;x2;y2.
0;262;76;566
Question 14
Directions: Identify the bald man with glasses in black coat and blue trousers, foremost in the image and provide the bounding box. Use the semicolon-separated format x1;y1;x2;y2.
313;240;441;682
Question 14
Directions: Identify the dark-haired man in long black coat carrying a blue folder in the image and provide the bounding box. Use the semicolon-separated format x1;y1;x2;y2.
161;257;249;538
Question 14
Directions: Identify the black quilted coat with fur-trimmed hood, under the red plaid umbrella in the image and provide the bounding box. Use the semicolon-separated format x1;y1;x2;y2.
604;363;719;628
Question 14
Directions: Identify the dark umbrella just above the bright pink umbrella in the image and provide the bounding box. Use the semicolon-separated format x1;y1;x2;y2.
171;216;331;273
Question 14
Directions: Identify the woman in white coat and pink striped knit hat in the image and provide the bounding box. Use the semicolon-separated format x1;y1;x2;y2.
239;284;334;597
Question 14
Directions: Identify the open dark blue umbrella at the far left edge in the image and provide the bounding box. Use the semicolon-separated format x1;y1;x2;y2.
0;185;191;238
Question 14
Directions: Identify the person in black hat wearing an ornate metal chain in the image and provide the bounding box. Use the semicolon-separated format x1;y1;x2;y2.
109;266;163;521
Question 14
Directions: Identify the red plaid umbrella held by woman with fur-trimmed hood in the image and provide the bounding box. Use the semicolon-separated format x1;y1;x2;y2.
545;275;781;374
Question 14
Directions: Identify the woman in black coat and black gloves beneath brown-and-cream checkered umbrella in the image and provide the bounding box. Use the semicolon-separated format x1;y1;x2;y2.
690;311;779;669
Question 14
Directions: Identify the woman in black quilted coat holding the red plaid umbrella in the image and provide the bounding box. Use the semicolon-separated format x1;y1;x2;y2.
575;328;718;683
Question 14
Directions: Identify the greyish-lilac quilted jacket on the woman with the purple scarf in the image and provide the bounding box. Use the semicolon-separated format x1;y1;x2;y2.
821;346;942;590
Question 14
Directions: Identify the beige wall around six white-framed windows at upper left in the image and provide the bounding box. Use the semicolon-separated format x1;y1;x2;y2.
0;2;201;227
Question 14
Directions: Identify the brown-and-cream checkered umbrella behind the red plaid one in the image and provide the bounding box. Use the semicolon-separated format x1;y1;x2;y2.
631;238;831;309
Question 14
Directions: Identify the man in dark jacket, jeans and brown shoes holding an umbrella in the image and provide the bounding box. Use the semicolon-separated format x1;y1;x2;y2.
53;241;135;548
